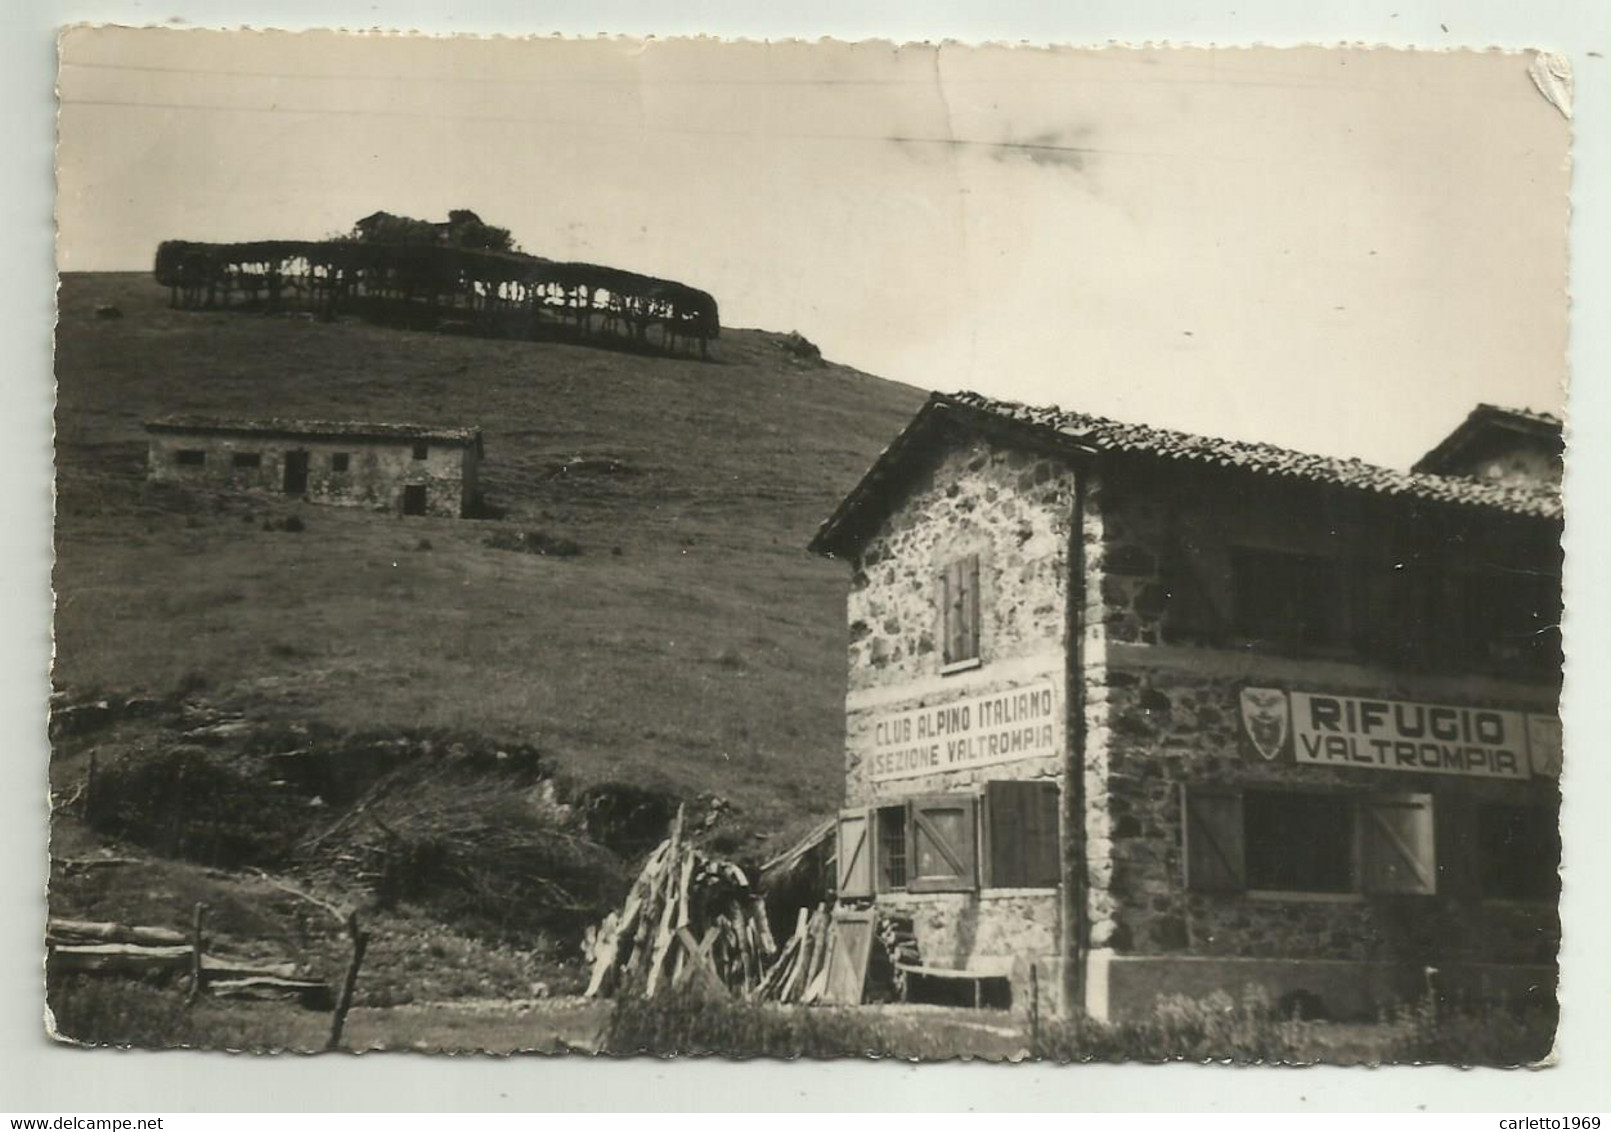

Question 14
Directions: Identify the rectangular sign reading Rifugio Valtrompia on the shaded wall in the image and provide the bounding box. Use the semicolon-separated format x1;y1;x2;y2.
1290;692;1530;778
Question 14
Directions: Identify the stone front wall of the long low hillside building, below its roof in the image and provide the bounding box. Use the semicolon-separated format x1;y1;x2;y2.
150;433;477;518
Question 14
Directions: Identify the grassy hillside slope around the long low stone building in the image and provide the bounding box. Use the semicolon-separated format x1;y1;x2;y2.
55;275;921;832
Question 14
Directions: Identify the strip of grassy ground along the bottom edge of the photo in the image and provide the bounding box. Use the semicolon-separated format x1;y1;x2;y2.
50;976;1555;1066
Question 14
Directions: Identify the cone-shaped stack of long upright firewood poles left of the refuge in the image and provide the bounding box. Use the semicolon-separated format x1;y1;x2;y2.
583;808;778;998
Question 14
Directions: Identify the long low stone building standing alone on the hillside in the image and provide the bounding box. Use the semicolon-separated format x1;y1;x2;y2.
145;417;482;518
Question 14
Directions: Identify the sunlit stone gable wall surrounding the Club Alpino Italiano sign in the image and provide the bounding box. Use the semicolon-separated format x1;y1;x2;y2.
846;438;1075;1010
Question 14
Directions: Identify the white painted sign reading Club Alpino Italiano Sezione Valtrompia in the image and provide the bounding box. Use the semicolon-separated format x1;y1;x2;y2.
867;680;1062;783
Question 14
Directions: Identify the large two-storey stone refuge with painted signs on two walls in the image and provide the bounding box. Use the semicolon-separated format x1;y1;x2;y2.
812;393;1561;1018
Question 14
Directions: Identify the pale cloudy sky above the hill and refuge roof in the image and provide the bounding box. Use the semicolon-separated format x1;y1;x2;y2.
58;27;1571;467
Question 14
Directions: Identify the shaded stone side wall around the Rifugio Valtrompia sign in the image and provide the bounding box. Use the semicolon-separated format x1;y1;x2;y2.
1086;463;1559;985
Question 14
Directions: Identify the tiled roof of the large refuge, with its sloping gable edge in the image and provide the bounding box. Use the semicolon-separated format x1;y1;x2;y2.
810;393;1561;554
